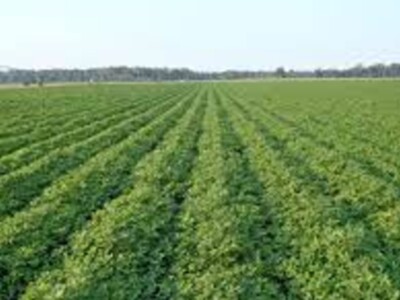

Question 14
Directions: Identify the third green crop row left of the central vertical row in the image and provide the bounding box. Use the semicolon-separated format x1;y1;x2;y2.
0;84;194;216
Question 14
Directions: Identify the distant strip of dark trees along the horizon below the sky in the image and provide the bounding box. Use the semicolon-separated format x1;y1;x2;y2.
0;64;400;85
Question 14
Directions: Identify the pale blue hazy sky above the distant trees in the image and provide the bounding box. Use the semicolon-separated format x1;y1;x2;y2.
0;0;400;70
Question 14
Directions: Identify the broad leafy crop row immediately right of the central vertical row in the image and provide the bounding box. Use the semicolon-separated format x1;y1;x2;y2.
222;86;399;299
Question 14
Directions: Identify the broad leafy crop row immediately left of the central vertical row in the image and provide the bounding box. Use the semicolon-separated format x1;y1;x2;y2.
22;85;205;299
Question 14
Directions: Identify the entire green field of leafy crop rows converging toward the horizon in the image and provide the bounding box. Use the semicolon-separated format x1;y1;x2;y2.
0;80;400;300
